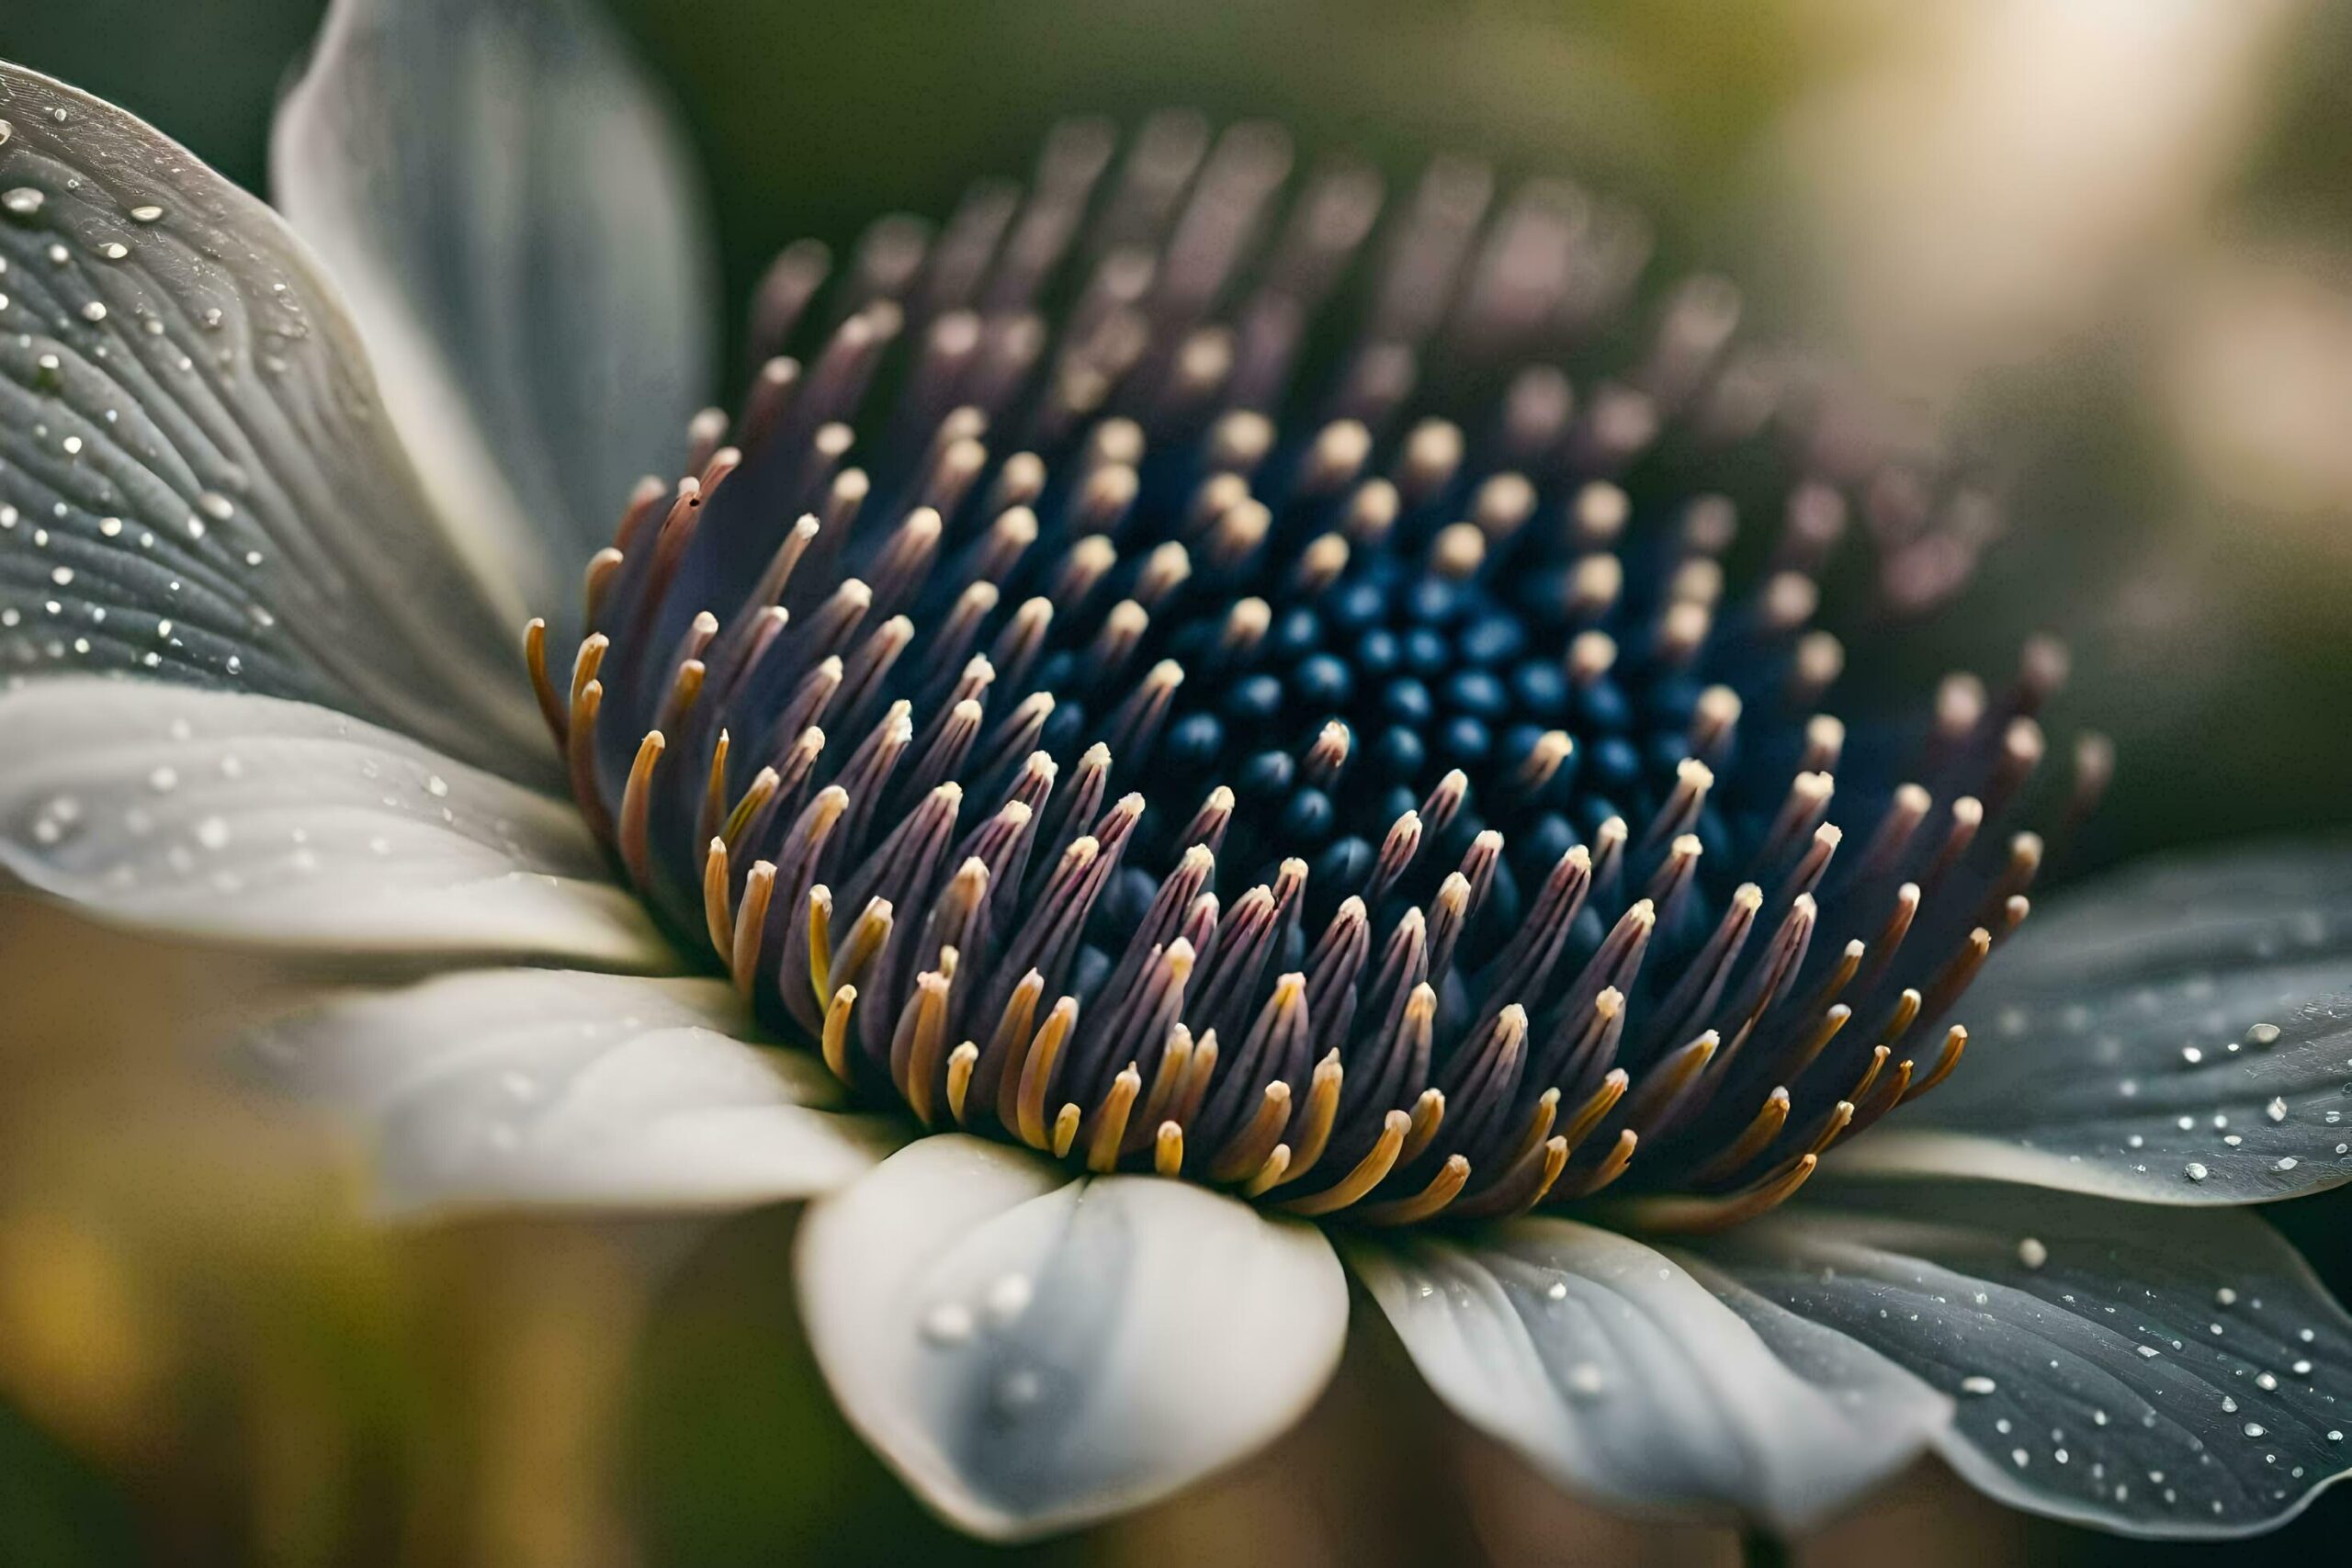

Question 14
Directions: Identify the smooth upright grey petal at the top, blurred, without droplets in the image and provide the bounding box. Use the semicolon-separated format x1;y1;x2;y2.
270;0;715;611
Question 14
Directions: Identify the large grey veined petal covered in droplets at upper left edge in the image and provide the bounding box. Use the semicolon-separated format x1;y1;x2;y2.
0;63;550;773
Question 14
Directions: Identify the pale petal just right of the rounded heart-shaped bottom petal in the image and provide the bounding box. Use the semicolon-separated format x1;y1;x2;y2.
1348;1220;1950;1530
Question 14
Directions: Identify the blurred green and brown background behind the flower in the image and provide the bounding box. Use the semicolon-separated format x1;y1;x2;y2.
0;0;2352;1568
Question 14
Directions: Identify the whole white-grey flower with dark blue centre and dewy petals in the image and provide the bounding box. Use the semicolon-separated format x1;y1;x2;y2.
0;0;2352;1538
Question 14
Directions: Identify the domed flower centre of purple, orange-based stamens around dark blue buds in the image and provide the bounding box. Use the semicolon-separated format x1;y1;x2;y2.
526;115;2108;1227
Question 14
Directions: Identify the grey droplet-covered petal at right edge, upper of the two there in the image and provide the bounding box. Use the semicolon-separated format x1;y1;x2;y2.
1871;844;2352;1203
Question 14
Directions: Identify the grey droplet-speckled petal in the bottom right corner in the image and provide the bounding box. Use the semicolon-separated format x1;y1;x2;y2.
1691;1178;2352;1535
